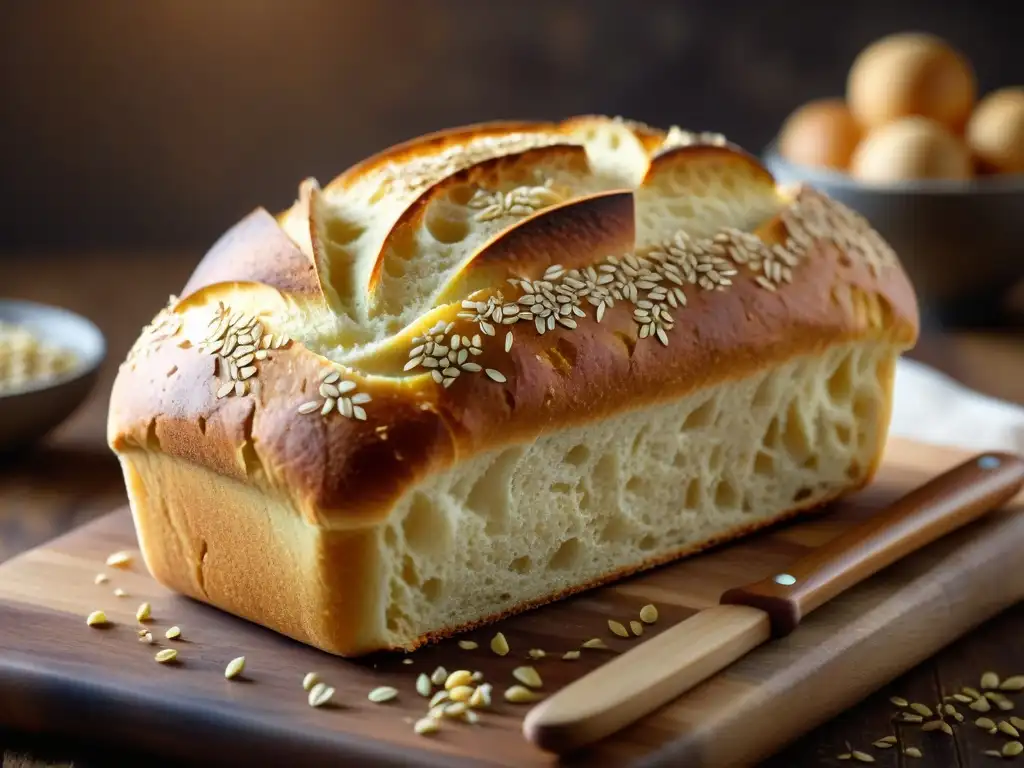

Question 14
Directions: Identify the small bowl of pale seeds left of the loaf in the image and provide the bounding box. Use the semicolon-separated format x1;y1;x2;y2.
0;299;106;453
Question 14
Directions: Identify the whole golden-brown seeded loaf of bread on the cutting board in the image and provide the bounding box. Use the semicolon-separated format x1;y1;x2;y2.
109;117;918;655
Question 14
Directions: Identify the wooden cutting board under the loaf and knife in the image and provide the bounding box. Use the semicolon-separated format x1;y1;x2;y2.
0;440;1024;767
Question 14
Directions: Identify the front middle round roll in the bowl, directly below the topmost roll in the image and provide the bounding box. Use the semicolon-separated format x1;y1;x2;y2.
850;117;973;182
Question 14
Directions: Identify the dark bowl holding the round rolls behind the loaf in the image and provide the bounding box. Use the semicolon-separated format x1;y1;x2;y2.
764;145;1024;326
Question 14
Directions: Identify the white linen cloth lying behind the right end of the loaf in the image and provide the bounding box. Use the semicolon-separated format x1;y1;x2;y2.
889;358;1024;452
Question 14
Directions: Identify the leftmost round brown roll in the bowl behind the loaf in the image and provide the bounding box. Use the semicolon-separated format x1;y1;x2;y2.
779;98;861;171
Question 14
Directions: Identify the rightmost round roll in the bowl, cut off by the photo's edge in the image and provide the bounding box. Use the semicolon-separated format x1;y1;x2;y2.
967;87;1024;173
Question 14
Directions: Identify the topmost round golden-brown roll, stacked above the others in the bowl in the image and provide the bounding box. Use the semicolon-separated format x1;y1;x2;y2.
847;33;977;131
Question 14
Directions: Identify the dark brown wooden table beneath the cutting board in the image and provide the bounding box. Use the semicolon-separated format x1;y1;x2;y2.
0;253;1024;768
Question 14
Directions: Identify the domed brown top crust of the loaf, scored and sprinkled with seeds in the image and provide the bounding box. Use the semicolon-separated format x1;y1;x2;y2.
109;116;918;527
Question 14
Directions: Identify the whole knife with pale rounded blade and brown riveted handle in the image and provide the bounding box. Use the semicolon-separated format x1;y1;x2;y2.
523;453;1024;754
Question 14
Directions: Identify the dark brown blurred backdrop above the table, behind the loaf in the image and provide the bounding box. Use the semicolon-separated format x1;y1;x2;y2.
0;0;1011;252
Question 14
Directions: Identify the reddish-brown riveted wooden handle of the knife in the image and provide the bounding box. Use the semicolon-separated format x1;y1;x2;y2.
721;453;1024;637
